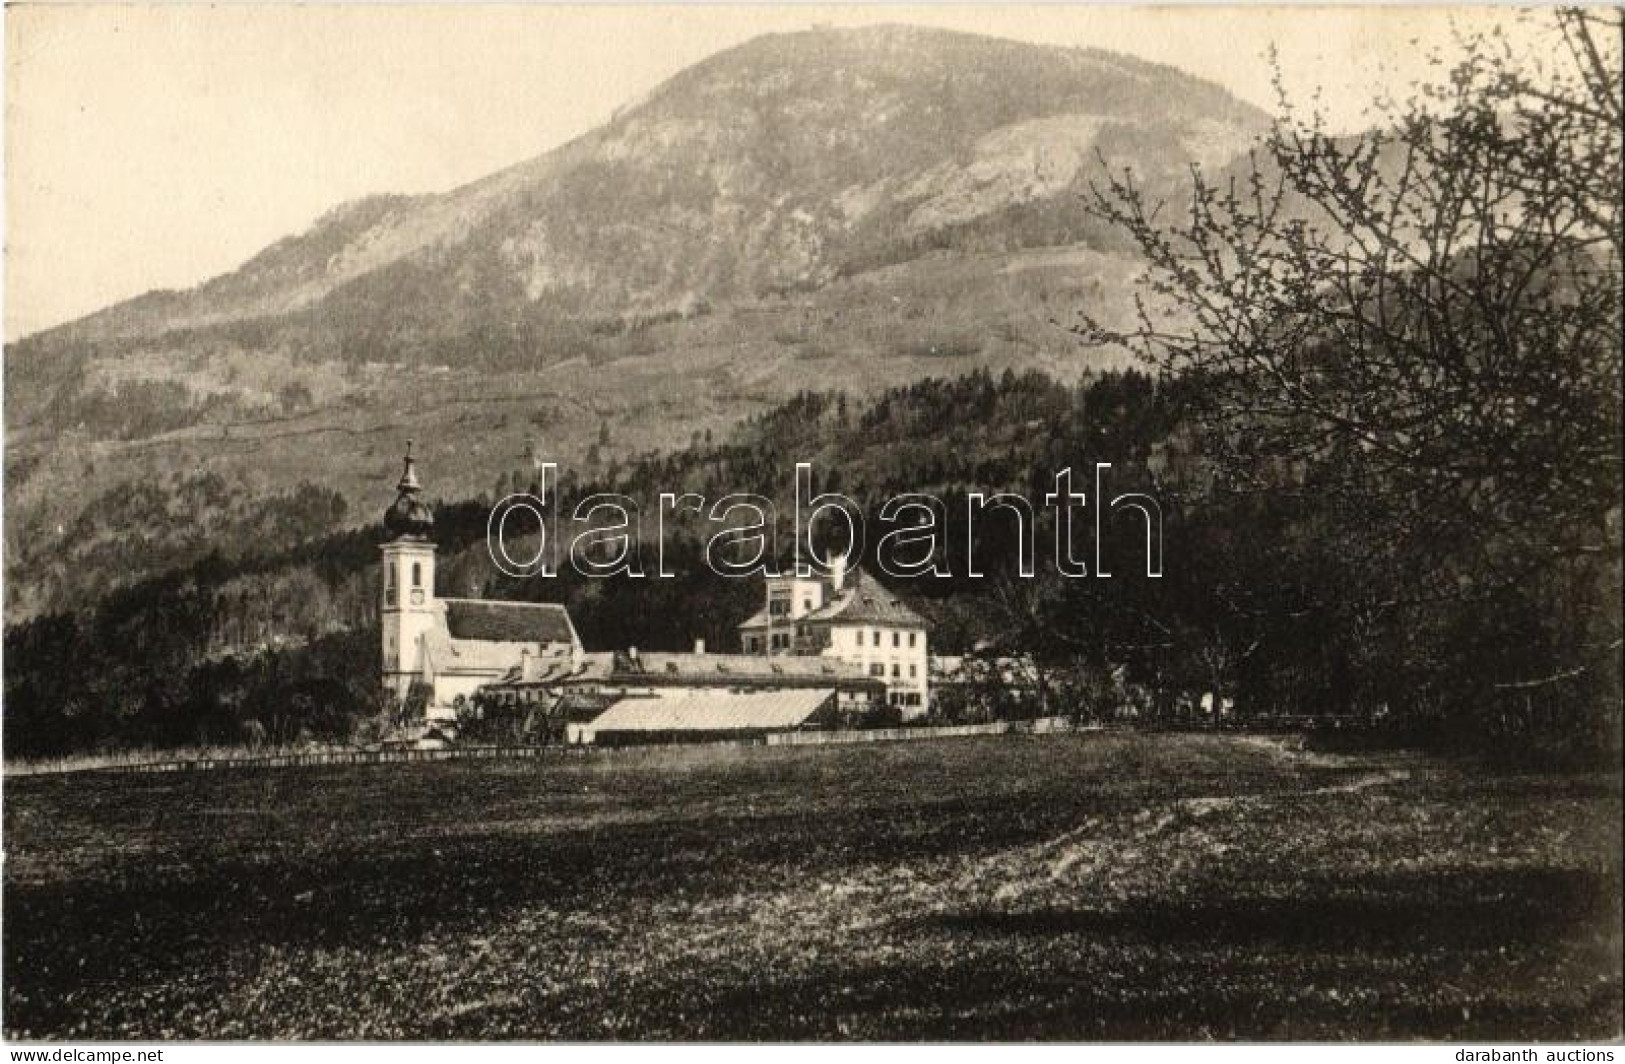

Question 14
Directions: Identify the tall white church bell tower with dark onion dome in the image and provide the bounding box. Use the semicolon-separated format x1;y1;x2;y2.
380;440;440;700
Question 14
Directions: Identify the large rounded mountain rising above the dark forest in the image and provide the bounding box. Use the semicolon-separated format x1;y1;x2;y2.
5;26;1266;619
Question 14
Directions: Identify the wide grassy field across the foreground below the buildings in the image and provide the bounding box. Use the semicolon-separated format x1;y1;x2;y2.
3;736;1622;1040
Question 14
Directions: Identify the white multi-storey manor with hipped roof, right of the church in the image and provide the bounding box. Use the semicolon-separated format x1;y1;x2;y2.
738;557;931;718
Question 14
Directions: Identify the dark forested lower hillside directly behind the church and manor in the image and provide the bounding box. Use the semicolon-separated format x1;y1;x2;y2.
5;357;1619;757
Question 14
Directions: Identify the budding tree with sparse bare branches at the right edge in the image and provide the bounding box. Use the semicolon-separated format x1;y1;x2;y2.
1081;10;1625;734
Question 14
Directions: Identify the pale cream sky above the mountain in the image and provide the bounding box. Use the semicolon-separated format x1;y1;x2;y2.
5;3;1547;340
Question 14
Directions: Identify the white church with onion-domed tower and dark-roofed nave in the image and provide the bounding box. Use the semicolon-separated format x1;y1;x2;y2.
380;440;582;720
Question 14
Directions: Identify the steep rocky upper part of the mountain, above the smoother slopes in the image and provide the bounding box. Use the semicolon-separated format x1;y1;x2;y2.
15;26;1264;357
